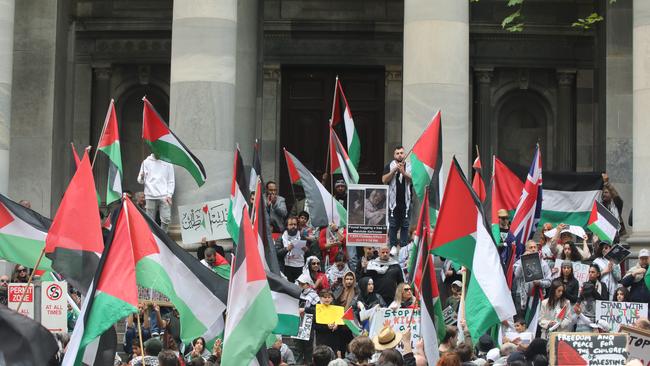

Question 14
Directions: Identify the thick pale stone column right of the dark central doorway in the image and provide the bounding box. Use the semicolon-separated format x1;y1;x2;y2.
402;0;471;170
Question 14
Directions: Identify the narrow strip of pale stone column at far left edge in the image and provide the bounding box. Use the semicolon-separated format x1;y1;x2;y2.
0;0;15;195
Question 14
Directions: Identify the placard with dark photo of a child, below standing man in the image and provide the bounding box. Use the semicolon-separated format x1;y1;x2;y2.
346;184;388;246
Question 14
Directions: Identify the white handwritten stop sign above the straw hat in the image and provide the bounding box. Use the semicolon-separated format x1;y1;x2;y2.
368;308;420;351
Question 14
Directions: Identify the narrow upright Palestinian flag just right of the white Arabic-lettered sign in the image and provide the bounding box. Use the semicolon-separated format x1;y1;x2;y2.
226;146;250;245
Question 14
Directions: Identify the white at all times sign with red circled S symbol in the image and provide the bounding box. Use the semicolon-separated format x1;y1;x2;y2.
41;281;68;333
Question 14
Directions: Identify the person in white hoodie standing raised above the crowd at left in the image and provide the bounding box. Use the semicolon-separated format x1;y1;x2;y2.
138;154;175;232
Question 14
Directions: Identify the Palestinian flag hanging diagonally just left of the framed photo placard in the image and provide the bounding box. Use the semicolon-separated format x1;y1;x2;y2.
284;149;348;227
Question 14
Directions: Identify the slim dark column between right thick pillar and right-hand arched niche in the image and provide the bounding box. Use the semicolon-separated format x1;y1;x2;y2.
470;67;493;174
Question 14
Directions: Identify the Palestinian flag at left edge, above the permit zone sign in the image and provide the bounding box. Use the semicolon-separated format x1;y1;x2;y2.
0;194;52;271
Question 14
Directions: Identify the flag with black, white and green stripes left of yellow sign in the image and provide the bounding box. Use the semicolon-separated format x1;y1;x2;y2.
266;271;301;336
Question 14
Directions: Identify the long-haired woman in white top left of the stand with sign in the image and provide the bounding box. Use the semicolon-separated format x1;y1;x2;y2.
539;280;573;339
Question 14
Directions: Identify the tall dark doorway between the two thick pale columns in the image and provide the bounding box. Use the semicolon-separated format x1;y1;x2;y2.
280;67;385;207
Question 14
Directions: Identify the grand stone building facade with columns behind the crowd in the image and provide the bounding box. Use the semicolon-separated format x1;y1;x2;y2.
0;0;650;253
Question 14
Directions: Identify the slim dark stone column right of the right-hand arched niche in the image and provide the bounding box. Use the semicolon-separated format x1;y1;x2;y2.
554;70;576;171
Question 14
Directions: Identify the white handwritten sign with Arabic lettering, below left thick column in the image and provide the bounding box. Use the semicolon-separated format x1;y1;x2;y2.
178;198;230;244
